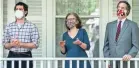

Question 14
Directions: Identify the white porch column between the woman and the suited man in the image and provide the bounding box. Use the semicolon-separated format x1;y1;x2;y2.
99;0;110;68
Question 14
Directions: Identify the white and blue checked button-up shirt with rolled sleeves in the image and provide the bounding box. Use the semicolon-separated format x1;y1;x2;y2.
3;20;39;52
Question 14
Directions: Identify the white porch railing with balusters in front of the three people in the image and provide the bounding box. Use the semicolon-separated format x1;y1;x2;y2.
0;58;139;68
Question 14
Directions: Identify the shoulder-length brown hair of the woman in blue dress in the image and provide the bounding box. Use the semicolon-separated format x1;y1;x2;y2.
65;12;82;30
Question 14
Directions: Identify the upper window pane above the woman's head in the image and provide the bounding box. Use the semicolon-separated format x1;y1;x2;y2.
56;0;99;15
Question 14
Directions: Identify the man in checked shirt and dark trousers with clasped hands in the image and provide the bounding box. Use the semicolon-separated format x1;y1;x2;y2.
3;2;39;68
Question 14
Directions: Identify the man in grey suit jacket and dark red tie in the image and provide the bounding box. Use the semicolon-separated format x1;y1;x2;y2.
103;1;139;68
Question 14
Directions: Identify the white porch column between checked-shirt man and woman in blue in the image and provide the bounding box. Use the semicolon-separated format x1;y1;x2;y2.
44;0;55;57
